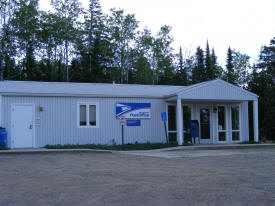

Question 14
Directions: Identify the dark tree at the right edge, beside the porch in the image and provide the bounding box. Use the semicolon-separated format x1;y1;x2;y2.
247;38;275;141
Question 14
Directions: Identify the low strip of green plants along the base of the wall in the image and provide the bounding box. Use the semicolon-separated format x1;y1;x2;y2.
45;143;178;150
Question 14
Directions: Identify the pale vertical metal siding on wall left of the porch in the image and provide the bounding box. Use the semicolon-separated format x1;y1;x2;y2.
2;96;166;147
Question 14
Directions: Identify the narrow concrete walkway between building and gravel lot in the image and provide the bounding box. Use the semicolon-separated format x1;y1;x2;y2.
0;144;275;154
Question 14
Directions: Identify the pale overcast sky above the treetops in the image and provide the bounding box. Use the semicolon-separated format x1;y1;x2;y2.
40;0;275;64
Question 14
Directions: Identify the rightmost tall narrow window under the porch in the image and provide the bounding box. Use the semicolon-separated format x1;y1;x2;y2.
231;105;241;141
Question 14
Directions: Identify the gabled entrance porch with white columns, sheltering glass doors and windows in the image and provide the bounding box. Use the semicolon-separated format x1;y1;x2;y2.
166;80;259;145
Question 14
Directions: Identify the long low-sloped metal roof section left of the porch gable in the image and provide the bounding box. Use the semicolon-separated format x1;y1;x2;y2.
0;81;186;98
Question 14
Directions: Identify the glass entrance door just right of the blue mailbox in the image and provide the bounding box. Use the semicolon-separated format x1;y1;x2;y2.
200;106;212;144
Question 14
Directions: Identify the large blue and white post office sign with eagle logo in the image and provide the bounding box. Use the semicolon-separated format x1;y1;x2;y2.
116;103;151;119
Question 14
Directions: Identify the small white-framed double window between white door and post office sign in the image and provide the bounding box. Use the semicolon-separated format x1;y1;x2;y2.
77;102;99;128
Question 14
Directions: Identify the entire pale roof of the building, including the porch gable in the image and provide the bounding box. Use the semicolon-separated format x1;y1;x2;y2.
0;79;258;100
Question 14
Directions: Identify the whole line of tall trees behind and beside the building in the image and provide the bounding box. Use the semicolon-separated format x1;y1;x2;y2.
0;0;275;139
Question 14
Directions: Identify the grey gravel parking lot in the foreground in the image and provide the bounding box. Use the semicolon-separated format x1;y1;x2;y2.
0;148;275;206
